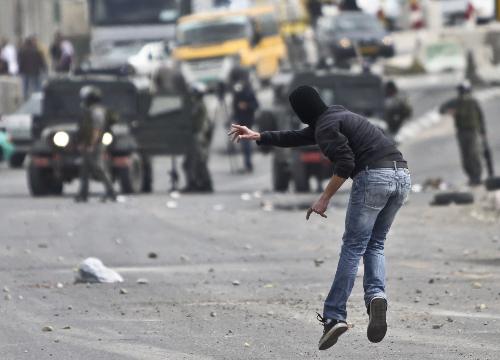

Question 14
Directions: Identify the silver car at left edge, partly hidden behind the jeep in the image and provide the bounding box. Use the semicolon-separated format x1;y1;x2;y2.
0;93;43;168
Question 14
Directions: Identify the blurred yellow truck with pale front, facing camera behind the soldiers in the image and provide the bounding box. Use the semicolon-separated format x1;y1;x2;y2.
174;6;286;88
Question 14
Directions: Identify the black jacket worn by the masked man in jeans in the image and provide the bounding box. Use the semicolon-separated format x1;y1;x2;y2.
258;105;404;179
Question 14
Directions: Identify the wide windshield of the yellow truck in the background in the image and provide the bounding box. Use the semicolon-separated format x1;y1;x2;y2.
177;16;251;46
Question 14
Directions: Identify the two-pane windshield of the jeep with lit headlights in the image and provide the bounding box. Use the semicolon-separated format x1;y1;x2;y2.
43;84;138;121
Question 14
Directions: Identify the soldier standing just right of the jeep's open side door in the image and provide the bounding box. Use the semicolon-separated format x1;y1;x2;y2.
183;84;214;193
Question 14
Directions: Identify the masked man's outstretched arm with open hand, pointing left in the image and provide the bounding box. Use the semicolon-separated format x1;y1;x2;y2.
228;124;316;147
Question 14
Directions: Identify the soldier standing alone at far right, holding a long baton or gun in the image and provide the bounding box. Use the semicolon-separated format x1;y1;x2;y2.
440;81;486;186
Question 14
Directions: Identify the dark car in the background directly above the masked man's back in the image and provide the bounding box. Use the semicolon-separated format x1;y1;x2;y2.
316;11;394;64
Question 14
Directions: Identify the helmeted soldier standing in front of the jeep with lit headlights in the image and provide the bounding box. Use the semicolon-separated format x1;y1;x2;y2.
75;86;116;202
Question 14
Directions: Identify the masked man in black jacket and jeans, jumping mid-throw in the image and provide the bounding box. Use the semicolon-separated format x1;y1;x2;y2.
229;86;411;350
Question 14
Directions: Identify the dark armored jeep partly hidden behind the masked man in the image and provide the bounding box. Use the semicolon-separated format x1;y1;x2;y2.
257;70;386;192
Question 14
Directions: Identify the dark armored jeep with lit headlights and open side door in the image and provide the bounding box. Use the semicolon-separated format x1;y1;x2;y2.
28;75;192;196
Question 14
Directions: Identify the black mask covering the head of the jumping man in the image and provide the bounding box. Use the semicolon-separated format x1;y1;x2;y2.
289;85;328;125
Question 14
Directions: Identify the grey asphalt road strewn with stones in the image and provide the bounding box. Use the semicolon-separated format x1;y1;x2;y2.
0;83;500;360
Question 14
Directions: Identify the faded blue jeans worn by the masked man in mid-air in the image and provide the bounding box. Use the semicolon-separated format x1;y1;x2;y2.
323;168;411;321
